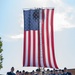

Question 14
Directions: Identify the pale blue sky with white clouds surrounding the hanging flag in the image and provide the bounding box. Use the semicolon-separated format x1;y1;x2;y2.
0;0;75;74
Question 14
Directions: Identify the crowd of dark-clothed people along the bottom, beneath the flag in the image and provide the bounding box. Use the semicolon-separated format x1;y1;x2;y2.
7;67;72;75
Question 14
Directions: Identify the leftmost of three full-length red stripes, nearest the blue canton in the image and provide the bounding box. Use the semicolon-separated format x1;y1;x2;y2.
42;10;46;67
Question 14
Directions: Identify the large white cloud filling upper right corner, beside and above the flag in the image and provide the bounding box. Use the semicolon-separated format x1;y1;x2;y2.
48;0;75;31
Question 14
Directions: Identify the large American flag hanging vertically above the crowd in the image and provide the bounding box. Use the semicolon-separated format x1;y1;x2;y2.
23;9;58;68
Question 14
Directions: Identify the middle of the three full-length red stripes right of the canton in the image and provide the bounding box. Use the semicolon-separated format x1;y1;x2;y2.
46;9;52;68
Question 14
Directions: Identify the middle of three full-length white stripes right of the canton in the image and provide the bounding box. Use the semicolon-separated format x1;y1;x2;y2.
44;10;49;67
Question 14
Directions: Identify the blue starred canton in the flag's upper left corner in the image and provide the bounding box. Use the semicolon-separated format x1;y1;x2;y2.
24;9;40;31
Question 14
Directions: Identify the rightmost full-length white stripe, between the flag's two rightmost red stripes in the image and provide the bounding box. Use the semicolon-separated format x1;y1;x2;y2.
48;10;55;67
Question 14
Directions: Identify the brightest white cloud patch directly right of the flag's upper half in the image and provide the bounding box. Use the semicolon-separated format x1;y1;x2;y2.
54;8;75;31
